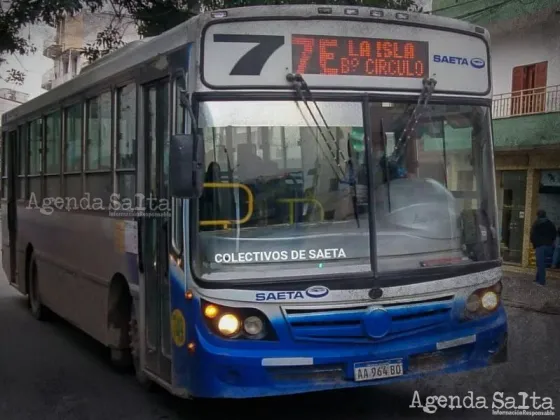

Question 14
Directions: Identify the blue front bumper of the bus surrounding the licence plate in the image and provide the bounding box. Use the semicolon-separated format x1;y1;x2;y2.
188;307;507;398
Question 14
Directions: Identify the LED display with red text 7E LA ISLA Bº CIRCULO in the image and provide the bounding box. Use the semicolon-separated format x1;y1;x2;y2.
292;34;429;79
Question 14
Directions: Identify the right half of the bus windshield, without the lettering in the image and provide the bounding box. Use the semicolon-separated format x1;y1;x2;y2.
370;103;498;272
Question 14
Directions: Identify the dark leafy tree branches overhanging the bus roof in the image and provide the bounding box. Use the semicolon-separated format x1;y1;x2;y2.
0;0;421;84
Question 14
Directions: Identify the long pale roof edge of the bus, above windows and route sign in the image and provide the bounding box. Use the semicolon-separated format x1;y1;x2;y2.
2;5;489;126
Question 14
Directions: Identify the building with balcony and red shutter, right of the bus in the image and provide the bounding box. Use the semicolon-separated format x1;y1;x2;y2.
432;0;560;267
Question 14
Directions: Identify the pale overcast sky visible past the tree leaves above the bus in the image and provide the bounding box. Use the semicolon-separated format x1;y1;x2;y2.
0;0;432;99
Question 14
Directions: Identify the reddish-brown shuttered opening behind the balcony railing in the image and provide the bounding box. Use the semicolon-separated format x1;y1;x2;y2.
511;61;548;115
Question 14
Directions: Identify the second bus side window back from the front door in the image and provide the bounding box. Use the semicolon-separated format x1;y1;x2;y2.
86;92;111;171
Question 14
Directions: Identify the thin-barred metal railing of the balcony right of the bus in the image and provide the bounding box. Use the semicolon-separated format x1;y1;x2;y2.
492;85;560;119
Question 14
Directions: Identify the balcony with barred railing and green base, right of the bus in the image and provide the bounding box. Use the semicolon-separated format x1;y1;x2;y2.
492;86;560;150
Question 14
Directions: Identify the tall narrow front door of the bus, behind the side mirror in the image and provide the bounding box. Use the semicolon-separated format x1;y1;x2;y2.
142;79;171;383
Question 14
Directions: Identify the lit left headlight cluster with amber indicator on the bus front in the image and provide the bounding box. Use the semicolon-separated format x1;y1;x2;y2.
201;300;278;341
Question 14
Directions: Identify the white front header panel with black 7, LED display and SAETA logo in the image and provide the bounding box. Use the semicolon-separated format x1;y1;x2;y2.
201;18;491;97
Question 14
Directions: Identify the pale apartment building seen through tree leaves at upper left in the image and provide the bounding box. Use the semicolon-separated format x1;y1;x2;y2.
41;7;139;90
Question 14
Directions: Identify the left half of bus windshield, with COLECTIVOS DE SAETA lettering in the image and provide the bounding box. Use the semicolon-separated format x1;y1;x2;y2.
195;101;370;279
